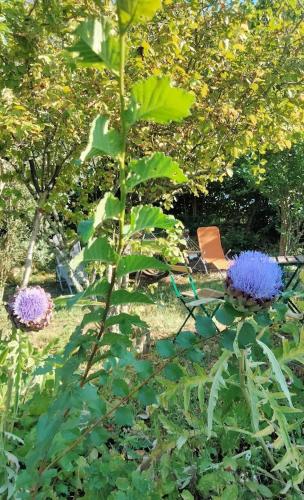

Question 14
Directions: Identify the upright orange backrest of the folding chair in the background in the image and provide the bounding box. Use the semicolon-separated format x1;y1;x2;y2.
197;226;225;262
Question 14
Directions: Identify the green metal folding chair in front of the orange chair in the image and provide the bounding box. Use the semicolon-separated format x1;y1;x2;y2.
170;264;224;335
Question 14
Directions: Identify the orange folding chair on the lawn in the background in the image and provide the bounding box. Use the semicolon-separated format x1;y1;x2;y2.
197;226;230;272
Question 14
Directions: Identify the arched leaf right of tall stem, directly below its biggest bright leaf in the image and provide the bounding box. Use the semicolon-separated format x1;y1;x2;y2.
126;153;187;191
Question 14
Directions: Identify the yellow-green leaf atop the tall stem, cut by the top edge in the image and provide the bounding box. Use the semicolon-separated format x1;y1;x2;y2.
117;0;161;30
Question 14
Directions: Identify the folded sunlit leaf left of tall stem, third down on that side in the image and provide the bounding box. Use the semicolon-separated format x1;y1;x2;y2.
78;193;121;243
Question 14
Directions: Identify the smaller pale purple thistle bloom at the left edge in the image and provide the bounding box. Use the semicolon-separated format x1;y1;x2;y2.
8;286;53;331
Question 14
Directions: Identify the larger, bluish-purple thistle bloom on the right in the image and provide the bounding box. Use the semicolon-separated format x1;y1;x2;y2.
227;251;283;301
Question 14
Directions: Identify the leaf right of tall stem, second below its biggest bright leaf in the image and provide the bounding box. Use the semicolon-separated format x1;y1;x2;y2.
125;205;176;236
